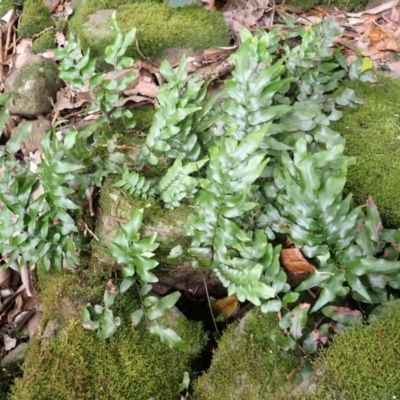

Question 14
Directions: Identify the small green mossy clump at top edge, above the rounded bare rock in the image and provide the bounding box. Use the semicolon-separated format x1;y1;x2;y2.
18;0;53;38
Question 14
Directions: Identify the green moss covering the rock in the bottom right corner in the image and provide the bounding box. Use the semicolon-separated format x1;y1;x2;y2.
315;302;400;400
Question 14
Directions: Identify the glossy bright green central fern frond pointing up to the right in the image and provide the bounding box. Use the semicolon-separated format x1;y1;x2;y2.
186;126;282;305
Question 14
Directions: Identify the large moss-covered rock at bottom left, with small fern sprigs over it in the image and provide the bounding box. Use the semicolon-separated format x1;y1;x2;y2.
11;262;205;400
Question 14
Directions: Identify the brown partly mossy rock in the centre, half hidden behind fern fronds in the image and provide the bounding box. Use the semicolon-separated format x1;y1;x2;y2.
95;177;226;298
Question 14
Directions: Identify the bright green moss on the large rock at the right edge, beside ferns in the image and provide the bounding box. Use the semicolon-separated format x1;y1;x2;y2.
331;77;400;227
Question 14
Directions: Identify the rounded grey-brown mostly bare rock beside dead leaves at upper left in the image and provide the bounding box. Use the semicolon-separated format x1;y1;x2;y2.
5;55;62;116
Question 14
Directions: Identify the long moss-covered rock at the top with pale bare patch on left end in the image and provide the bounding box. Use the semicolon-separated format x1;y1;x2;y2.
69;0;231;59
